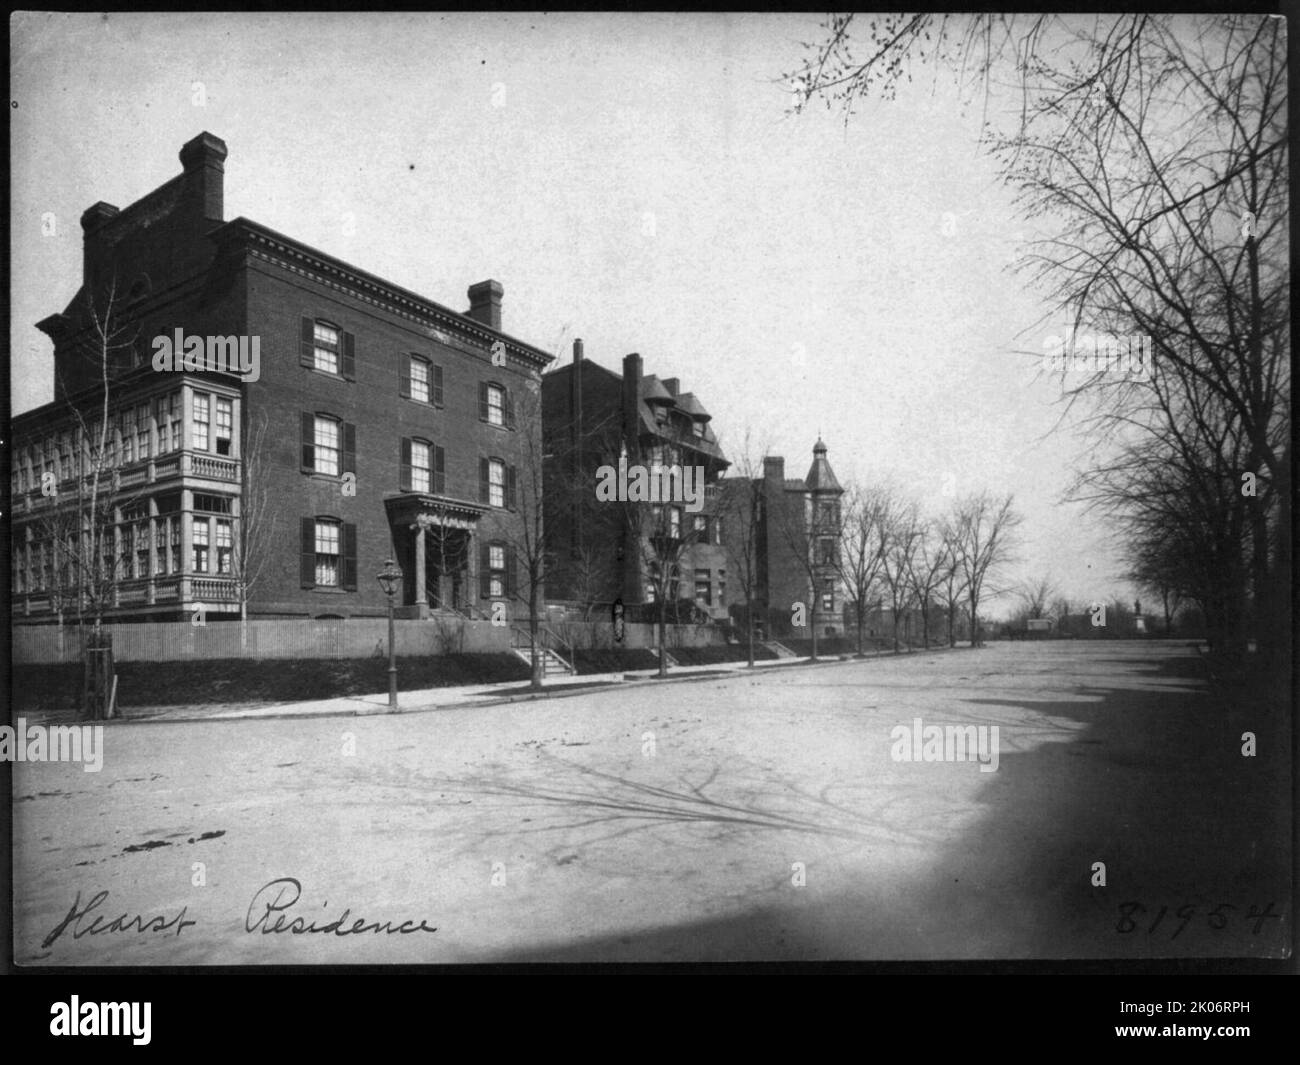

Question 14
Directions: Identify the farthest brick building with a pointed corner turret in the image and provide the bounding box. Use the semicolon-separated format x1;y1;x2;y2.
722;440;844;636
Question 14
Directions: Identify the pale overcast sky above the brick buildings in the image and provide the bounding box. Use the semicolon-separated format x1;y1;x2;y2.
10;14;1131;614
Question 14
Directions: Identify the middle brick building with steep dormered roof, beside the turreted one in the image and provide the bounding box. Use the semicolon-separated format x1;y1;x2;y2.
542;341;729;619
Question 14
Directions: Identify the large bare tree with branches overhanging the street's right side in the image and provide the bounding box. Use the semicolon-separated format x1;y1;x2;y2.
780;13;1292;661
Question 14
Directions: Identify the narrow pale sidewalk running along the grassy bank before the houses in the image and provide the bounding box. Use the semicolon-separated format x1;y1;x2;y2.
114;655;842;723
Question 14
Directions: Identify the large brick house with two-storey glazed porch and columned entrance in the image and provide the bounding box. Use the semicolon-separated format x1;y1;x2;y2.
12;133;551;622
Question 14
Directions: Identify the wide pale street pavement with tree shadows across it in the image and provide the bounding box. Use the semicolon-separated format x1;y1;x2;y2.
13;641;1292;965
